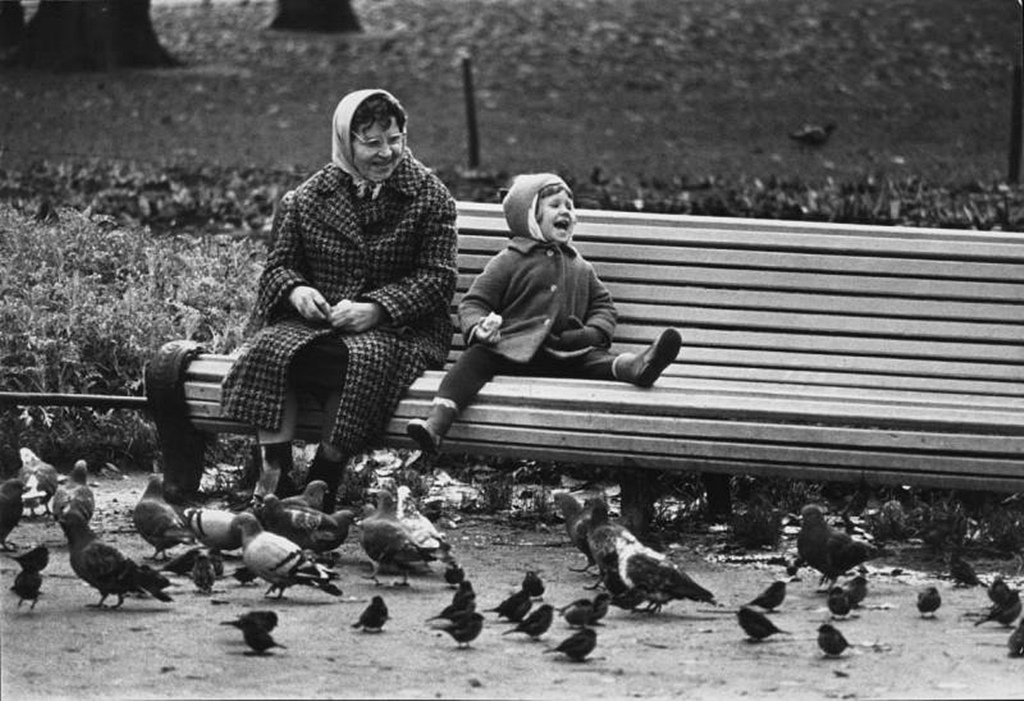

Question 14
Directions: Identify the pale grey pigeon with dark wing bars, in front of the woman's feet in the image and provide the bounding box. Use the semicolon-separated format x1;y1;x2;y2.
234;512;342;599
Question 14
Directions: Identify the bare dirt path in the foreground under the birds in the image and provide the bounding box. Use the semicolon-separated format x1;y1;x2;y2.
0;466;1024;700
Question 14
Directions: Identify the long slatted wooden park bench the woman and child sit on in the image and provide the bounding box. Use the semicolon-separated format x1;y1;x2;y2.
146;203;1024;527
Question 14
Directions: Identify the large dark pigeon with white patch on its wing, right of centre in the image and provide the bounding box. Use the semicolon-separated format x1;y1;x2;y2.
588;498;715;613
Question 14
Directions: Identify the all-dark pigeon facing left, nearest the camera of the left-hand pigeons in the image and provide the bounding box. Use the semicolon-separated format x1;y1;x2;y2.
60;507;173;609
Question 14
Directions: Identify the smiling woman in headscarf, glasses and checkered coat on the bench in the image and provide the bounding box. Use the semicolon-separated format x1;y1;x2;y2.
223;90;457;512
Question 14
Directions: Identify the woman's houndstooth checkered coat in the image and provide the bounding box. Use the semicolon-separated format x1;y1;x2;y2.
223;150;458;454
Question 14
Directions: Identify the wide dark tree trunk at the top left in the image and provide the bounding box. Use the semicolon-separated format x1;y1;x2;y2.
10;0;179;71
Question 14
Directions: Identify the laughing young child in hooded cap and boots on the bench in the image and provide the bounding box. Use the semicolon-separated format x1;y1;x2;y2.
407;173;682;452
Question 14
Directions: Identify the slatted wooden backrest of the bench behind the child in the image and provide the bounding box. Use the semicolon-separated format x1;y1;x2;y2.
454;203;1024;396
